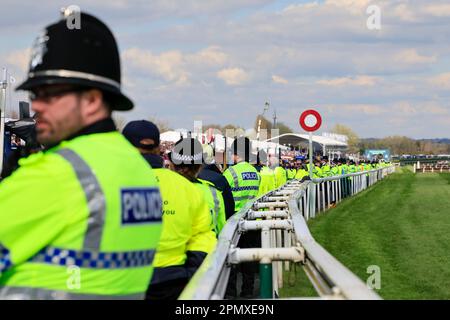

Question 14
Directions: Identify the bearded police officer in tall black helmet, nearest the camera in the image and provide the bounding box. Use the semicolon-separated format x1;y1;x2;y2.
0;13;161;299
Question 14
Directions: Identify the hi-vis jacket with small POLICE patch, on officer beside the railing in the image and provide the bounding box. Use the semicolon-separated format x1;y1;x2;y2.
223;161;261;212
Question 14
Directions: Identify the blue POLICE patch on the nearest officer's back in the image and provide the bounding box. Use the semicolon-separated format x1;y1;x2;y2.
120;188;162;225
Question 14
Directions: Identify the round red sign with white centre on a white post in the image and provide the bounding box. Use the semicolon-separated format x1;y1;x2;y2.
299;110;322;218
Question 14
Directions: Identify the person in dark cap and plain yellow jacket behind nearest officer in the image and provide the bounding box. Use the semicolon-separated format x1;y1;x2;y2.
123;120;215;300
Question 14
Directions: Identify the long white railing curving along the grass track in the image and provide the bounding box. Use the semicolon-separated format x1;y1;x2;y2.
179;167;395;300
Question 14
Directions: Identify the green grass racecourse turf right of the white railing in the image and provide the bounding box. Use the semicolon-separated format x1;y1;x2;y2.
280;168;450;299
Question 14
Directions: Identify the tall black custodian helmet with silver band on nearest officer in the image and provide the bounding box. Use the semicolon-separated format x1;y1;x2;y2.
16;10;133;110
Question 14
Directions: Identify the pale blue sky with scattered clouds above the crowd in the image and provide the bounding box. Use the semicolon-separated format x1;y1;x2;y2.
0;0;450;138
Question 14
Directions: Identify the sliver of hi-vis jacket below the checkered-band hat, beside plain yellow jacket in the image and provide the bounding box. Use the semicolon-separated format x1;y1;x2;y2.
197;179;227;236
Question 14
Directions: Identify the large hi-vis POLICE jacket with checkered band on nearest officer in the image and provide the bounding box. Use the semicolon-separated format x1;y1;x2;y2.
0;131;161;299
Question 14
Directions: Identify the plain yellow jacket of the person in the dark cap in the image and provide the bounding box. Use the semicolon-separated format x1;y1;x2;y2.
152;168;216;284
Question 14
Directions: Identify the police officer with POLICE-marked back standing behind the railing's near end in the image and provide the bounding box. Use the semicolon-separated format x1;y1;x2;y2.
224;137;261;298
